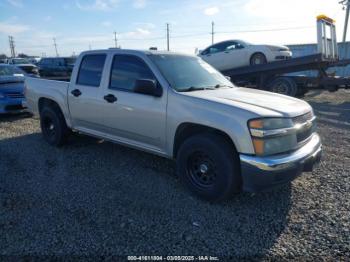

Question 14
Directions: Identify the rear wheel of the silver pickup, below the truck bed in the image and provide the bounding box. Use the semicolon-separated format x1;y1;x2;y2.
40;106;70;147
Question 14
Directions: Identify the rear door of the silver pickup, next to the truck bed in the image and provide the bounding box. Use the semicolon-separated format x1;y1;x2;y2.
68;53;107;133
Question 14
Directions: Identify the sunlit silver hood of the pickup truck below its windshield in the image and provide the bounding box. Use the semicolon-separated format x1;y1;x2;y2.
180;88;312;117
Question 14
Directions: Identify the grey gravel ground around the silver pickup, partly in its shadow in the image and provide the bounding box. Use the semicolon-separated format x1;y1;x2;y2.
0;91;350;261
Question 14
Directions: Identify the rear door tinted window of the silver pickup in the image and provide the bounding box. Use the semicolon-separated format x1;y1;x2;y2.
77;54;106;87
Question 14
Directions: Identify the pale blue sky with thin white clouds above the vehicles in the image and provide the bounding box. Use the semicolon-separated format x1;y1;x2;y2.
0;0;345;56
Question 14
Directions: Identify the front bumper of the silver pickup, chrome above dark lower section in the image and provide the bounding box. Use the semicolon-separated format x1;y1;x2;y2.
240;134;322;192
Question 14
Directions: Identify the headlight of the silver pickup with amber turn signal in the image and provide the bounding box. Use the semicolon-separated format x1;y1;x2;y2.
248;118;297;156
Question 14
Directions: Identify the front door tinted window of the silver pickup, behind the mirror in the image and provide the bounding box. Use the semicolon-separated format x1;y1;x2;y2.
109;55;155;91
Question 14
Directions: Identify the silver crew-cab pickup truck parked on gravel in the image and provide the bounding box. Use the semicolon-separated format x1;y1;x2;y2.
25;49;321;200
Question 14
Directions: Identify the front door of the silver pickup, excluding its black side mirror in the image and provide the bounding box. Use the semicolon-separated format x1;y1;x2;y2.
100;54;167;152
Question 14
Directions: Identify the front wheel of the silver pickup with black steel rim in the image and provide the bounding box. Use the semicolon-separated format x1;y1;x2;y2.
176;133;241;201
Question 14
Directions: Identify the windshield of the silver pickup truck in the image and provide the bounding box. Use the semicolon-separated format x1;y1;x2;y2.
149;54;233;92
